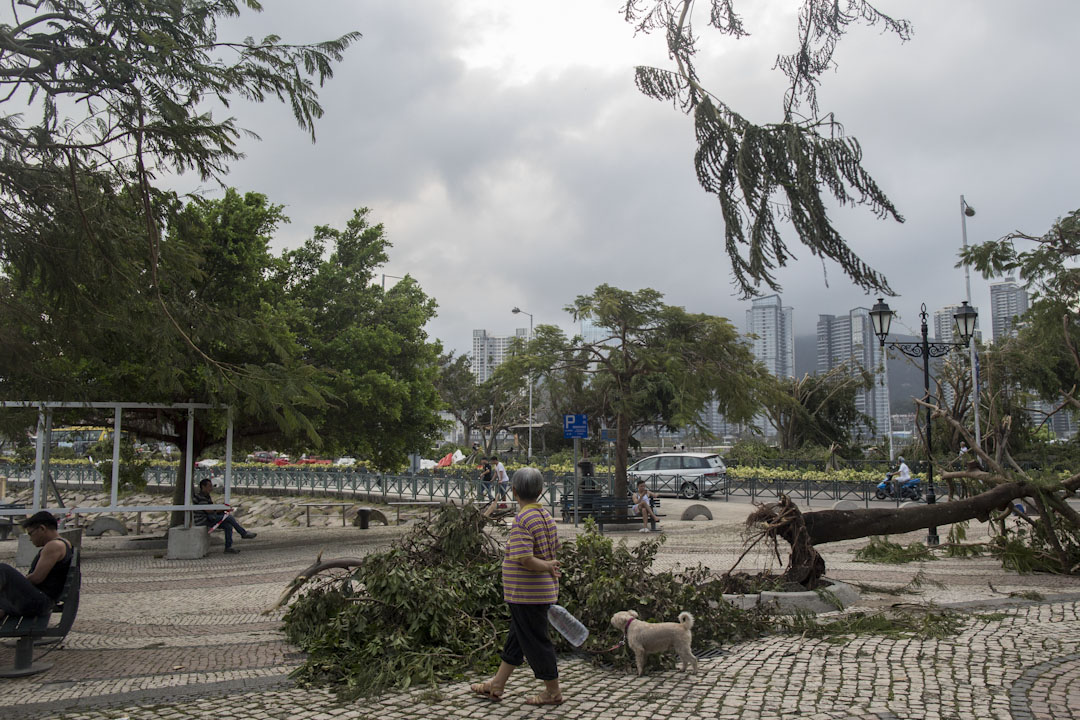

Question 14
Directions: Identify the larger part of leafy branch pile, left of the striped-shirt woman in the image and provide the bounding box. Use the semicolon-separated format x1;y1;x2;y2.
285;506;509;697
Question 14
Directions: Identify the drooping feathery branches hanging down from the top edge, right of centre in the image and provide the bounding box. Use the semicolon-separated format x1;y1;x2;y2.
622;0;912;296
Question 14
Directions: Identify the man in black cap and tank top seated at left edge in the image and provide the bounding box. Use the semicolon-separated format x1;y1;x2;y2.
0;510;71;621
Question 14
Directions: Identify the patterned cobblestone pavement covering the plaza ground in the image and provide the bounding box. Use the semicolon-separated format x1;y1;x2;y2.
0;500;1080;720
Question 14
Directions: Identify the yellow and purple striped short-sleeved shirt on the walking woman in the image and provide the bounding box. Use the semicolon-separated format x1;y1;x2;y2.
502;503;558;604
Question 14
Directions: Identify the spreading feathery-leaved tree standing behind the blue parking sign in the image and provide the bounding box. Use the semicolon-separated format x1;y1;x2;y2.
531;285;761;495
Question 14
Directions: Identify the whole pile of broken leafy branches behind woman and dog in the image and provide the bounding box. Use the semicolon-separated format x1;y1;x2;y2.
285;505;769;697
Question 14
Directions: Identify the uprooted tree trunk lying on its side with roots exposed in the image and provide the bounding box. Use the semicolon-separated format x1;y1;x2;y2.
746;403;1080;588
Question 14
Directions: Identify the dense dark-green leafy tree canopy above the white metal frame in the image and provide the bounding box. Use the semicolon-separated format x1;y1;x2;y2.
0;191;438;520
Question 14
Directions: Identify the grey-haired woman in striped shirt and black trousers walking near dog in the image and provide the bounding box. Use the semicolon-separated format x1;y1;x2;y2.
471;467;563;705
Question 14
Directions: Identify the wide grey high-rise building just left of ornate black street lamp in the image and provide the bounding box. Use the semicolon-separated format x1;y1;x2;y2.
818;308;890;437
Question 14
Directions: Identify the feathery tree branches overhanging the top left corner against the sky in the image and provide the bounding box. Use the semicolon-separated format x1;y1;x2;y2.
0;0;359;382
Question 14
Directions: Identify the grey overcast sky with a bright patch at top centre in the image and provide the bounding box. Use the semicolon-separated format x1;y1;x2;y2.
188;0;1080;352
